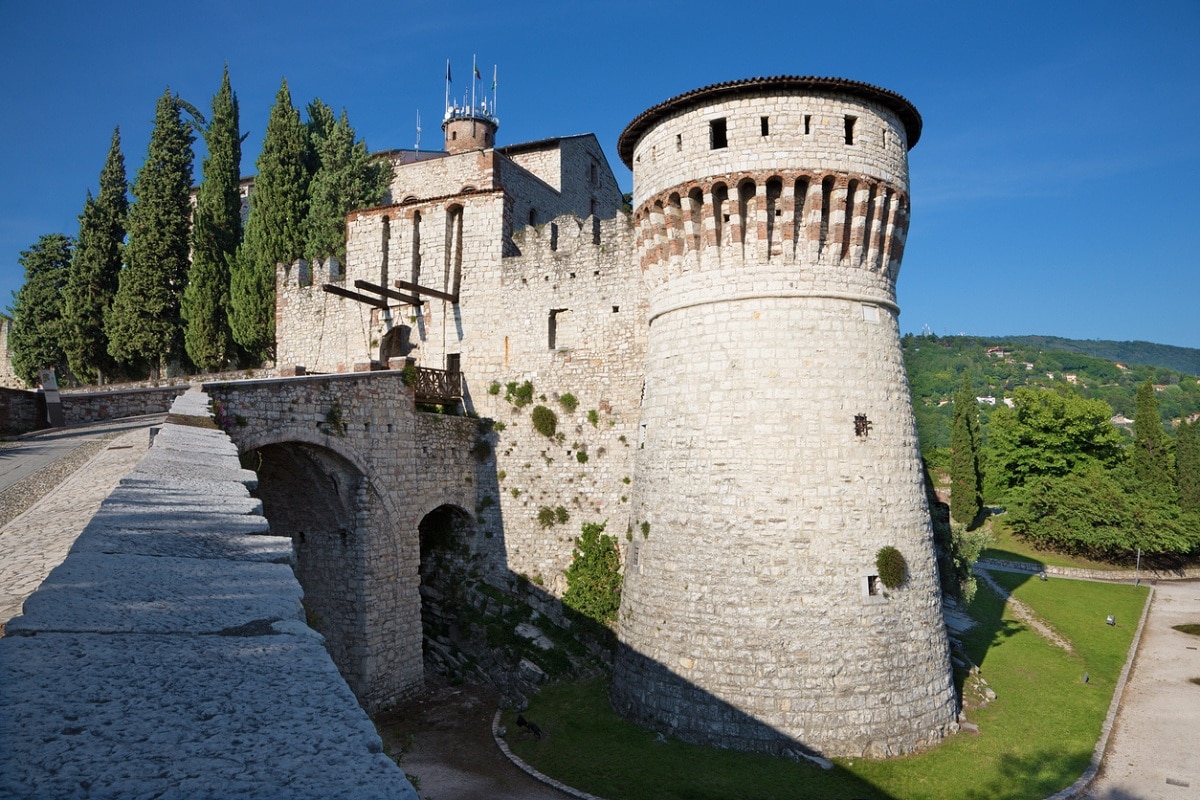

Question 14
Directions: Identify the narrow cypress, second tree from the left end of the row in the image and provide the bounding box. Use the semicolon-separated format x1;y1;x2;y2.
62;128;130;384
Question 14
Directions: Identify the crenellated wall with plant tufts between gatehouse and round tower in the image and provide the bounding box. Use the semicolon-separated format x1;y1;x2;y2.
462;215;647;595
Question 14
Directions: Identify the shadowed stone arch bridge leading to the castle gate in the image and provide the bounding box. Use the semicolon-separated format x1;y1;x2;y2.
204;371;496;710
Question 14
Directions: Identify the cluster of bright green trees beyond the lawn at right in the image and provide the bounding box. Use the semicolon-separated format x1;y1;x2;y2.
948;373;1200;560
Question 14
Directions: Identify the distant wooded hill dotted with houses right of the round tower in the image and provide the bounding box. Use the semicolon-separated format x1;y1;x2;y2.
901;333;1200;455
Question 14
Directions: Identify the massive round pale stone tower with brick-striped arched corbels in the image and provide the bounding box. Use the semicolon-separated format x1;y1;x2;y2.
612;77;956;757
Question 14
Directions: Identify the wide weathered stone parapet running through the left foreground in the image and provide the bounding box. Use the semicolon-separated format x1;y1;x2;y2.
0;392;416;800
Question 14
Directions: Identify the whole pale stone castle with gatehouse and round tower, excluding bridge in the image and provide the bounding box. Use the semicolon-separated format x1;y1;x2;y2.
276;77;955;756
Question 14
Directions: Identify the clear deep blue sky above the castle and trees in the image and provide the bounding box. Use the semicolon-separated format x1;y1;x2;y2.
0;0;1200;347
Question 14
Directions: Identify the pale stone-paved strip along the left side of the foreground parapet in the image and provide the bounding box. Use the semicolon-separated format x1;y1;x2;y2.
0;416;162;631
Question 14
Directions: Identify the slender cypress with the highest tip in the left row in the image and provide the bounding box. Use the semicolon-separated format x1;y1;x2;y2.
182;65;241;369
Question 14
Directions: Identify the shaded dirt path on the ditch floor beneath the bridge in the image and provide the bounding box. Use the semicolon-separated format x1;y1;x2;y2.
376;684;570;800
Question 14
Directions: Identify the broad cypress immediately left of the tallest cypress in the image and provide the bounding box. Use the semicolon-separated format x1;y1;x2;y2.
104;89;193;375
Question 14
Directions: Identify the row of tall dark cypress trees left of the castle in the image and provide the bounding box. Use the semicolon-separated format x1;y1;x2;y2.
8;67;392;385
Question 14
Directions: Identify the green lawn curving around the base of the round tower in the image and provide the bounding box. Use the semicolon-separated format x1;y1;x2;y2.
503;573;1147;800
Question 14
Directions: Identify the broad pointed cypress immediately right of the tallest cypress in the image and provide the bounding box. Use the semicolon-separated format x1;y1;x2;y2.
229;80;310;357
